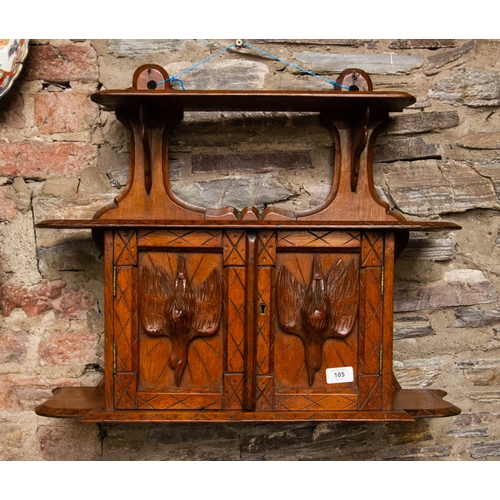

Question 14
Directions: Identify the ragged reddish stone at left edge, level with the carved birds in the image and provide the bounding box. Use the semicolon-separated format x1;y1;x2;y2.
0;280;66;318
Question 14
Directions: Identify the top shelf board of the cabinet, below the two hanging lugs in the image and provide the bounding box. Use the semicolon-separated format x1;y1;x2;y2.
91;88;416;112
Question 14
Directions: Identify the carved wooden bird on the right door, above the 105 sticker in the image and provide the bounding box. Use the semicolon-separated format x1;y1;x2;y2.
278;255;359;386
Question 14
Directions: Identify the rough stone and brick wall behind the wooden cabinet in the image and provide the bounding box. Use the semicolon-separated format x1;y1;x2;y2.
0;39;500;460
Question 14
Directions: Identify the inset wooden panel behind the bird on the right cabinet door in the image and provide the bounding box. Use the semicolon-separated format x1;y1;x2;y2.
274;252;359;400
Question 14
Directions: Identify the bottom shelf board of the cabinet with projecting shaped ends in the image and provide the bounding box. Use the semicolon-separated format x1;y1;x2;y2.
35;387;460;423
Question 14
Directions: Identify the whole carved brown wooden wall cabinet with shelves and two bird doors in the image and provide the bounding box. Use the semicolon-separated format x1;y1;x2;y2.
36;65;460;422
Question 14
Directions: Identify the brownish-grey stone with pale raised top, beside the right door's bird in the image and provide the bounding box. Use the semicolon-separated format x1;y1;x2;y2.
394;269;498;312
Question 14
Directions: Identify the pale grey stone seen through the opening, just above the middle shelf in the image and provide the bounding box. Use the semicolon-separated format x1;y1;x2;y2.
172;173;299;210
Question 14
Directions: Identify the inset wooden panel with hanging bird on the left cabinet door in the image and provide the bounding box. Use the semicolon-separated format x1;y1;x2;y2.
138;249;225;409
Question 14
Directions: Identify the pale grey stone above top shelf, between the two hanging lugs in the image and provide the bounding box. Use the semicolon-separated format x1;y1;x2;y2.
166;59;269;90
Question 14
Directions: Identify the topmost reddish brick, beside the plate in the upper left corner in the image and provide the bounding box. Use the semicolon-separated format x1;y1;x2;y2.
25;44;98;83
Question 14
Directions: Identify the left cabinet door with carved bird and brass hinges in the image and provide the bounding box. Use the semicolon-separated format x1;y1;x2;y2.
113;230;226;409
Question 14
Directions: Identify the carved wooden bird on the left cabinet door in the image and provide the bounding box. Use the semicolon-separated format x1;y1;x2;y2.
140;255;222;386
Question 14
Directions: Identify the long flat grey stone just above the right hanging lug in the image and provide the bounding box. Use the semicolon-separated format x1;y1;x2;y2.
292;52;423;74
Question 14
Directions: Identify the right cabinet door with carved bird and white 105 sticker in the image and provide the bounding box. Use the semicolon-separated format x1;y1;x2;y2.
272;231;390;411
